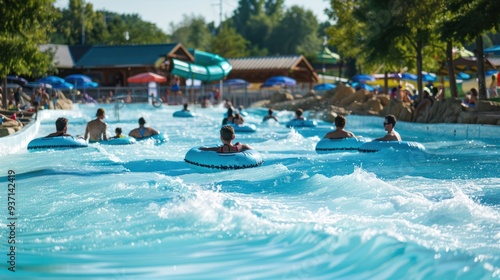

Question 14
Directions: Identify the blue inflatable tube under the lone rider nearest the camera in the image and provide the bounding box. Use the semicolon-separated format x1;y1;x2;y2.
184;147;264;170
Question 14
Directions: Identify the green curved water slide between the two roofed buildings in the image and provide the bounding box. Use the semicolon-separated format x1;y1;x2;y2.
170;49;233;82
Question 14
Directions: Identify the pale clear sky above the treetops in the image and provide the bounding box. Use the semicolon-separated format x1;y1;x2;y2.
56;0;329;33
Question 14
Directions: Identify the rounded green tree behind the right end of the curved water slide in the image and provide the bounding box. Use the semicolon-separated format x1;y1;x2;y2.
210;24;248;58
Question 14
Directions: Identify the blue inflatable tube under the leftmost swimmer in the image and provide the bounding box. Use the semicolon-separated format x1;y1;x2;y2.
28;136;88;151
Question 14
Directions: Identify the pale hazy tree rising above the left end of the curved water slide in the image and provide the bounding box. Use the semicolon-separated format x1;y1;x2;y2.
170;15;211;50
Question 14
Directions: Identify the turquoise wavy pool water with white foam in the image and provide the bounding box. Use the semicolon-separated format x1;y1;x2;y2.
0;104;500;279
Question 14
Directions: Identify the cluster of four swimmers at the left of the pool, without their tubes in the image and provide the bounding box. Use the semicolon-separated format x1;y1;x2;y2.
46;108;160;143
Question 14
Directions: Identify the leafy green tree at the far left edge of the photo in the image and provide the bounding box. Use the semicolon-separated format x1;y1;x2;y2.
0;0;59;107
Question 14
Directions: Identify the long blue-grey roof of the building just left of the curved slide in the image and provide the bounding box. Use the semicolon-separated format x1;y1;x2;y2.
75;43;188;68
